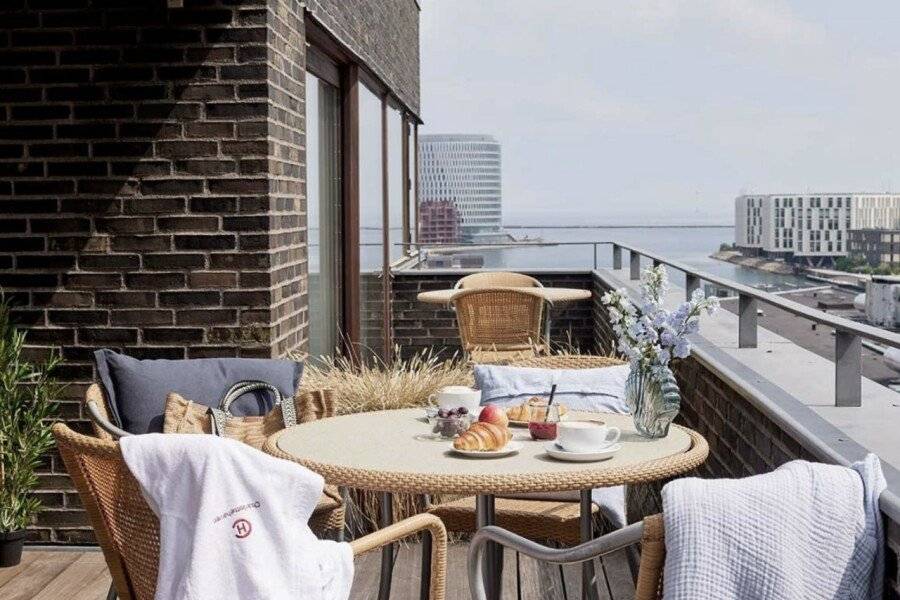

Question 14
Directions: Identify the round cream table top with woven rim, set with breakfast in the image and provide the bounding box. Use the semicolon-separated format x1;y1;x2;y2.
266;408;709;494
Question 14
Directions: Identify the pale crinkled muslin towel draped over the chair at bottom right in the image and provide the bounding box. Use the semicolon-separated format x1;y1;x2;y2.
662;454;885;600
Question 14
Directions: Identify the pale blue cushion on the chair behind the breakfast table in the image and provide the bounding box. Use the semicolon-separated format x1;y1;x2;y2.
474;365;630;413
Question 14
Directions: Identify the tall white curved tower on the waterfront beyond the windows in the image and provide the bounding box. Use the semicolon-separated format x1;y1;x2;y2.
418;134;503;242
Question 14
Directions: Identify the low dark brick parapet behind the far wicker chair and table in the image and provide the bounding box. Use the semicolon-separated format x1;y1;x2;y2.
392;271;594;356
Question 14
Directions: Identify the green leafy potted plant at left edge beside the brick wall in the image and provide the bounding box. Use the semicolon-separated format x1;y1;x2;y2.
0;298;62;567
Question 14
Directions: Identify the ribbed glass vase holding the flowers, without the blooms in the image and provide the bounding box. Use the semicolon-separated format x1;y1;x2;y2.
625;366;681;438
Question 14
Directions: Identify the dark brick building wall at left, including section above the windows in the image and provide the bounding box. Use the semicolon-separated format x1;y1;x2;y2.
0;0;418;543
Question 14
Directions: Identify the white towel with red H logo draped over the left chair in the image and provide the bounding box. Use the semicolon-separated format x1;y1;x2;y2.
121;434;353;600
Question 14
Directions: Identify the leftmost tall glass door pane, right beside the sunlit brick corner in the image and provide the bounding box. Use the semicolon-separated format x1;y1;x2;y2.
306;73;343;359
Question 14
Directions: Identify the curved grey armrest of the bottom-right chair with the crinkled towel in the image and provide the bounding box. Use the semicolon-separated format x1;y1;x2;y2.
467;522;644;600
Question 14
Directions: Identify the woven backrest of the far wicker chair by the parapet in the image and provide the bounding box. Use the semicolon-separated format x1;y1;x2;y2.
453;288;544;352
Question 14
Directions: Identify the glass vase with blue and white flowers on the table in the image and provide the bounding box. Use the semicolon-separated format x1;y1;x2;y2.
601;265;719;438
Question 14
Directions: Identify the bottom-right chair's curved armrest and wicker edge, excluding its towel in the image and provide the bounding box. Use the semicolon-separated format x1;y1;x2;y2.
468;515;666;600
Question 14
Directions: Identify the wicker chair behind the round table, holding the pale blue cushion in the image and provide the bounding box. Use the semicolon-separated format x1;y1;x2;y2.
429;354;625;545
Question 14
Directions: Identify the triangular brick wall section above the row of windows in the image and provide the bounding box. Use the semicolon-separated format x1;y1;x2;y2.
306;0;420;114
